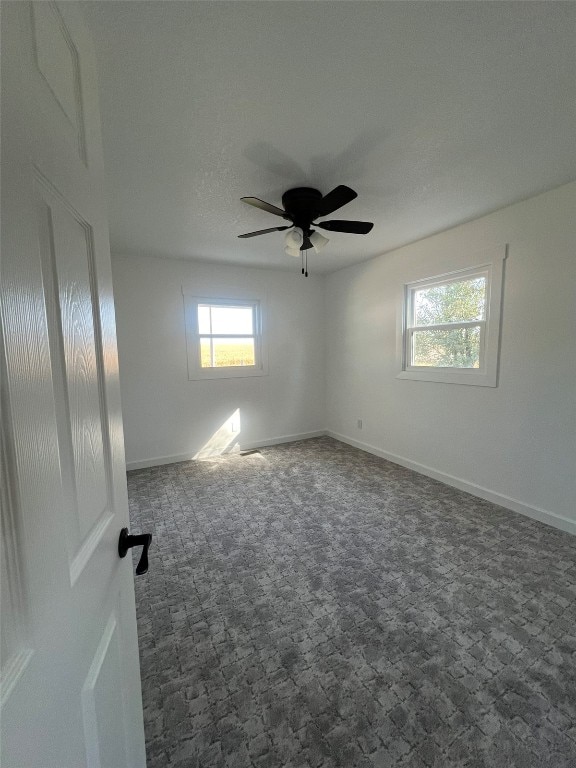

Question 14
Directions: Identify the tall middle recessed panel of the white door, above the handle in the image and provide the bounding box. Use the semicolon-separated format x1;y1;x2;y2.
38;180;111;564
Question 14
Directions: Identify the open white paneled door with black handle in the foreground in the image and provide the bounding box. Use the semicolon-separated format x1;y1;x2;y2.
0;1;150;768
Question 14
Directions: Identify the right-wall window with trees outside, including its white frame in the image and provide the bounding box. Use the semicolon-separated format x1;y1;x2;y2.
400;255;502;387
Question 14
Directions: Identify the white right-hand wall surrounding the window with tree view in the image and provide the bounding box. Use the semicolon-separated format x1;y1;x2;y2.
326;184;576;533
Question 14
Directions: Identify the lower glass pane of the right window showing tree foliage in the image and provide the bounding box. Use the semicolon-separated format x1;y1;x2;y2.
412;326;480;368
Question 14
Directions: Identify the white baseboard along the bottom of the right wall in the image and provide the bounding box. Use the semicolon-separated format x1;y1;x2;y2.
325;430;576;534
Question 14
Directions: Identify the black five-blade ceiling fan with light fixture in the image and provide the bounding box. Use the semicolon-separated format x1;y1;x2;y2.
238;184;374;275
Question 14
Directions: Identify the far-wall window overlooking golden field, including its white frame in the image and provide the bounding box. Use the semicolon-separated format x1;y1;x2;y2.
184;294;266;379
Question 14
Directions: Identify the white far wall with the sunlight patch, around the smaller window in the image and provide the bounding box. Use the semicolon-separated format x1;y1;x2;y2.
112;255;325;468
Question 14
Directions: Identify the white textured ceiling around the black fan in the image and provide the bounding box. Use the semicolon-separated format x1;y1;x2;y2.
81;0;576;272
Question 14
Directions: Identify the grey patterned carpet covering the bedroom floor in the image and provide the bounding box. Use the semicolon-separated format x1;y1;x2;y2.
128;438;576;768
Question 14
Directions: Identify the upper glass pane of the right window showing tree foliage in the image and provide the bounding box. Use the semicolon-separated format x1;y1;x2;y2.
414;277;486;324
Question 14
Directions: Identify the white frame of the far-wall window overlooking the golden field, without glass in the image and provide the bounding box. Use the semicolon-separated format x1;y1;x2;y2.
182;290;268;381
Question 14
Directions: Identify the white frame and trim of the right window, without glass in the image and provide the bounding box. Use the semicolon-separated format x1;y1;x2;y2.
397;252;506;387
